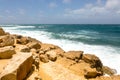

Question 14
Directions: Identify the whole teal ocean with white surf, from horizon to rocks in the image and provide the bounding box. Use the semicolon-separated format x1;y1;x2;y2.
0;24;120;74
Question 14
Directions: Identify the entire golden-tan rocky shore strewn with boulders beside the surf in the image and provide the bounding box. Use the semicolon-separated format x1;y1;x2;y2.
0;28;120;80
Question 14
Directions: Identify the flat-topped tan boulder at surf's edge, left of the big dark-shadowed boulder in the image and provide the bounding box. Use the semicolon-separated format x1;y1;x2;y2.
64;51;83;61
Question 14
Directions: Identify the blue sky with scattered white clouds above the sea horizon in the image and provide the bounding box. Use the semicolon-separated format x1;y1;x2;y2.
0;0;120;24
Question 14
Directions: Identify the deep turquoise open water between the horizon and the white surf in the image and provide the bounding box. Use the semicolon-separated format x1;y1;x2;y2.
2;24;120;47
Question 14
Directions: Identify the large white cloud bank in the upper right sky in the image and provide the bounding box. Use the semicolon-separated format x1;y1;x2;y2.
65;0;120;17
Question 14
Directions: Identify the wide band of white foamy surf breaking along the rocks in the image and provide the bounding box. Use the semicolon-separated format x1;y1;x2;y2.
3;26;120;74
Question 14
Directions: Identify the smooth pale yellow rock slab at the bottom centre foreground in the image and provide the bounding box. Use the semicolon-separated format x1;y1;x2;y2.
41;62;85;80
